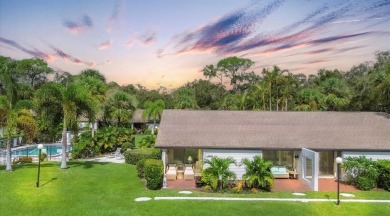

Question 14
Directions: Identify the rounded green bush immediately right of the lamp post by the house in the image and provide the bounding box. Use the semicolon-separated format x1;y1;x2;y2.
342;156;379;190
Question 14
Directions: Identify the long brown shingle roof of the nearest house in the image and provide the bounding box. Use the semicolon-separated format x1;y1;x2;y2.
156;110;390;151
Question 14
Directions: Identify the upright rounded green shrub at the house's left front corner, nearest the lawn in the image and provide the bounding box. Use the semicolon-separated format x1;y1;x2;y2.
144;159;164;190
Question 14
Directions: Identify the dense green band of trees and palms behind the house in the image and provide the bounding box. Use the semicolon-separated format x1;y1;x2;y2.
0;51;390;169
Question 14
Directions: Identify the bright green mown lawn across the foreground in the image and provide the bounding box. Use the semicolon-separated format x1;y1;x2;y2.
0;161;390;216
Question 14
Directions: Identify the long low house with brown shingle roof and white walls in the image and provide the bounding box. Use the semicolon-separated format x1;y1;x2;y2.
156;110;390;191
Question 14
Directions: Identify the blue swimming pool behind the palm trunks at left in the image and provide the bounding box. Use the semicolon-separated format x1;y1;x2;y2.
12;144;72;156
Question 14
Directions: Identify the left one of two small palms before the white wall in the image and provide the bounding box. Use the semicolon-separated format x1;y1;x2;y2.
204;156;236;188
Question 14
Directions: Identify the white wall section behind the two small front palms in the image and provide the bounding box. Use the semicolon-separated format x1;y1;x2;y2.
203;149;262;180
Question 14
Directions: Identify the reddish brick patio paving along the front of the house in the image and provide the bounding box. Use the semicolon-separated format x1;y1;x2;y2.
167;178;358;192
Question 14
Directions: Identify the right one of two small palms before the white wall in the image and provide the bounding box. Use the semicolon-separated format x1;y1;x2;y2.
242;155;274;190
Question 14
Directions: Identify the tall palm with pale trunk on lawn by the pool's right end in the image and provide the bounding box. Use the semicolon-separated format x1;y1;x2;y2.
35;83;96;169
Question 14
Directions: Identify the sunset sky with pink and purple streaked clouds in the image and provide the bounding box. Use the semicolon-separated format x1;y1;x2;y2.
0;0;390;89
